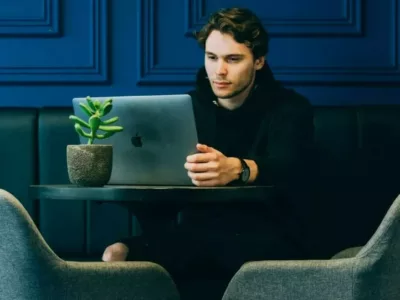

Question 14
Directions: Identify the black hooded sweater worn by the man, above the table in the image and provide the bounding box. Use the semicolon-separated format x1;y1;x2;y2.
190;65;314;185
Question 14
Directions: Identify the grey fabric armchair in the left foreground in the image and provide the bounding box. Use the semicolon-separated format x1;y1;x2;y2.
0;189;179;300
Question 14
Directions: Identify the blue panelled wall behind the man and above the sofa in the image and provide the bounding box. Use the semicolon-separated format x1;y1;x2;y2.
0;0;400;107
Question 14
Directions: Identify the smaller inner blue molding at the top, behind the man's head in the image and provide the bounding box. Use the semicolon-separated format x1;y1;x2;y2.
184;0;364;37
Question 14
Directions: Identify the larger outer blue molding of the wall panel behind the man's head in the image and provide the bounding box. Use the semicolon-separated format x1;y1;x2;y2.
137;0;400;85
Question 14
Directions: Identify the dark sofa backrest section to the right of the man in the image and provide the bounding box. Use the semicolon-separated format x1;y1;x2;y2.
315;106;400;252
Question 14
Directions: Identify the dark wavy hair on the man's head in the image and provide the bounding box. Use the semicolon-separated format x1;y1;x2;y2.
195;8;269;59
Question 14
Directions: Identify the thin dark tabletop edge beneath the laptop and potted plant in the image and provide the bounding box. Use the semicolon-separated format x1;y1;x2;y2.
30;184;274;202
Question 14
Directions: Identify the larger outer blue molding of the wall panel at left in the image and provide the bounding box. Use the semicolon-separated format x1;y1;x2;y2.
0;0;109;83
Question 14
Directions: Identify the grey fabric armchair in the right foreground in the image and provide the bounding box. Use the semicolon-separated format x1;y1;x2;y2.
223;196;400;300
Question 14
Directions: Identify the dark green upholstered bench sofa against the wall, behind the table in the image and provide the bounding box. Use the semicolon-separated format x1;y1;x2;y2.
0;106;400;259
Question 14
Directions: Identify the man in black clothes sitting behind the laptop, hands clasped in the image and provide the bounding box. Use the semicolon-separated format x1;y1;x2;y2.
103;8;314;298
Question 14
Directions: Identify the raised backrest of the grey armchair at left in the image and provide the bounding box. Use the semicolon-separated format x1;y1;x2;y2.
0;189;62;299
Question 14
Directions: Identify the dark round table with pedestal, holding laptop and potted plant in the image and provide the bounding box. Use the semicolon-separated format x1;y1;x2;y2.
30;184;275;234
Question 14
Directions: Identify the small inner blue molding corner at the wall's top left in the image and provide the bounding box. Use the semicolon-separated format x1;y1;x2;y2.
0;0;61;36
